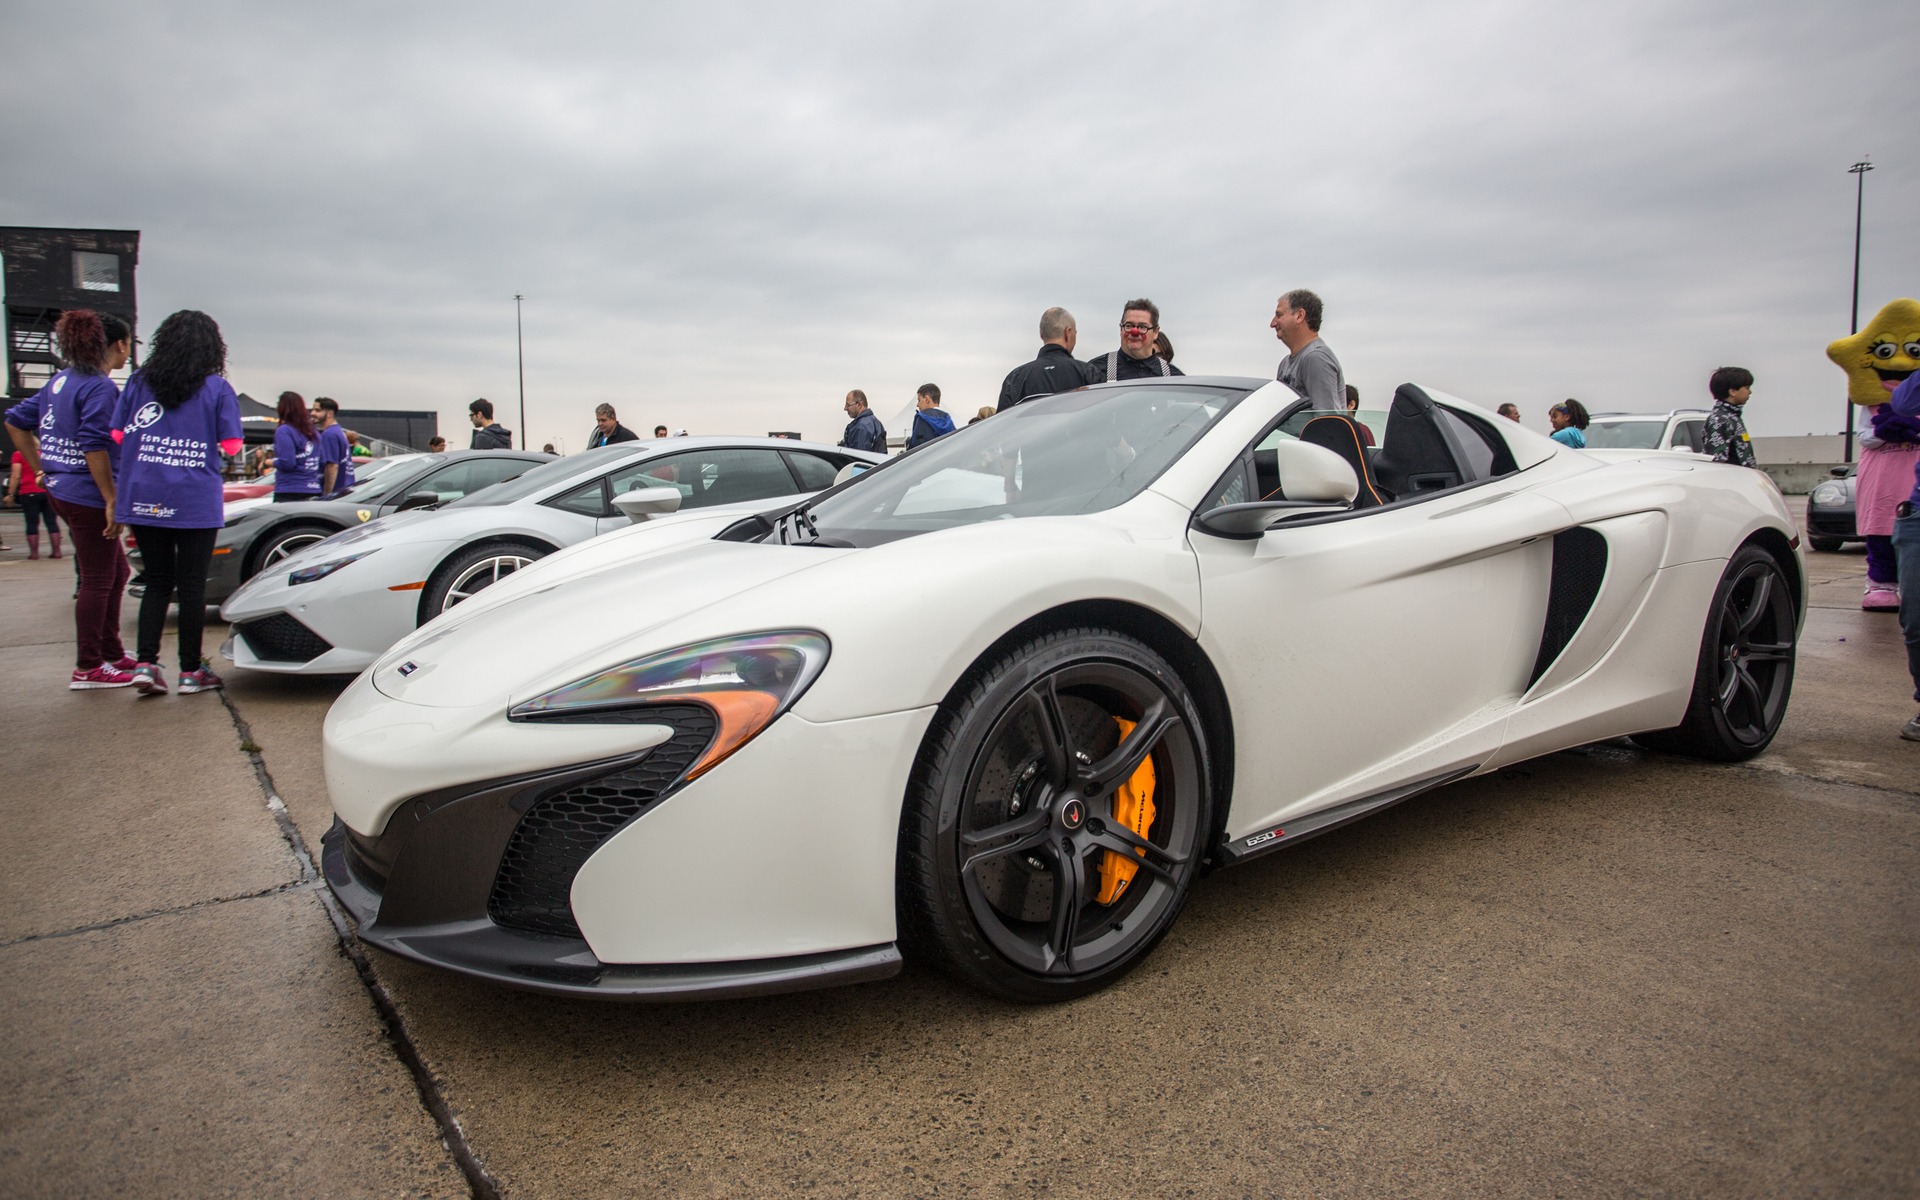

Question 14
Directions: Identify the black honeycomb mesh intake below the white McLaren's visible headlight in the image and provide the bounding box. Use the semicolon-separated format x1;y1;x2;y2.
486;705;716;937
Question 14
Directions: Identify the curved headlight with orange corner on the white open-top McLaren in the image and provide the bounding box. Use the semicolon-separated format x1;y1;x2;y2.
507;630;828;780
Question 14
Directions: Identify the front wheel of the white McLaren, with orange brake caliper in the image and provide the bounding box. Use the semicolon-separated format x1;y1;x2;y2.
899;628;1213;1004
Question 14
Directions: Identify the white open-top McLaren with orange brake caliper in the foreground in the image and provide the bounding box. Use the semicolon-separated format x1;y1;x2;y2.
324;378;1805;1002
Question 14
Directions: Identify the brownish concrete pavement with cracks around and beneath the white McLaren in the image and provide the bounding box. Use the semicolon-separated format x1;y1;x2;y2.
0;506;1920;1196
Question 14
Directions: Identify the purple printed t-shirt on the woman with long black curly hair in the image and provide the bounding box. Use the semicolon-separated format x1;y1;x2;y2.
113;372;242;530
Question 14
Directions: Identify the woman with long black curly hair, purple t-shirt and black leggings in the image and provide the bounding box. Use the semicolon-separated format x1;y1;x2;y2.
113;309;242;695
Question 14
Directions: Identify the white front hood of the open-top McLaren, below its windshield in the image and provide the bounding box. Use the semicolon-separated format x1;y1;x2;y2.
372;522;844;708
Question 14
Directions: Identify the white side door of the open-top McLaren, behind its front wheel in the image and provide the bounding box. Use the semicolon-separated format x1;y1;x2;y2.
1190;408;1569;839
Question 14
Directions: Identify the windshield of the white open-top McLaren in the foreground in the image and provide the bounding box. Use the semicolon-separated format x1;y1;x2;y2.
804;380;1250;545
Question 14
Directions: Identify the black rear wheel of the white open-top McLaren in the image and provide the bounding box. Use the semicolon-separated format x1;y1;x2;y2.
1634;545;1799;762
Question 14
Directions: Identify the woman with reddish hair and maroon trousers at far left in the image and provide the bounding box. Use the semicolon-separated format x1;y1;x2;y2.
6;309;132;691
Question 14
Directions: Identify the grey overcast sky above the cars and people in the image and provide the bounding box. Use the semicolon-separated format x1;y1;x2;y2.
0;0;1920;449
